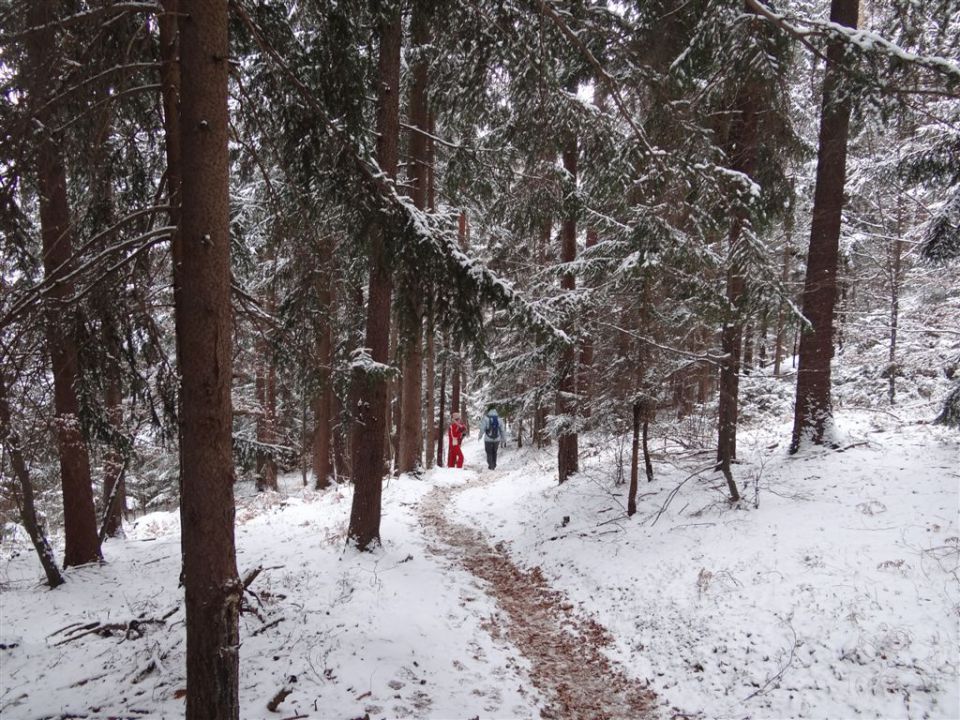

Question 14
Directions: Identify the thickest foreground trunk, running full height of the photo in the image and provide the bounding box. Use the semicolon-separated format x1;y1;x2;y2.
176;0;243;720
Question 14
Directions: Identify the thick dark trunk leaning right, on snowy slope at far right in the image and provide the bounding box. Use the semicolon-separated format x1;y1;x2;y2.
790;0;859;453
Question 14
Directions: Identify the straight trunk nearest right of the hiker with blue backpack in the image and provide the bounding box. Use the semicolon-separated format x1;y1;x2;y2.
556;137;580;483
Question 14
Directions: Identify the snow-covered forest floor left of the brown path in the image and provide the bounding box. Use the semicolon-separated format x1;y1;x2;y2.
0;470;537;720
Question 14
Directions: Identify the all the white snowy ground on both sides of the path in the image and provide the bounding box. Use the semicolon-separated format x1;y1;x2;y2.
0;402;960;720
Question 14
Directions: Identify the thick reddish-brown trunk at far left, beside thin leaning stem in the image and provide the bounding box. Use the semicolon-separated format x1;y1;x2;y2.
26;0;100;567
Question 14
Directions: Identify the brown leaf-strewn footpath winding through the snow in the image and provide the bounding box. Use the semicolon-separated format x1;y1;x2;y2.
419;476;656;720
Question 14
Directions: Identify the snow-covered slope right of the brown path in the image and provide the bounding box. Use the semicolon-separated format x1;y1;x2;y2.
459;412;960;719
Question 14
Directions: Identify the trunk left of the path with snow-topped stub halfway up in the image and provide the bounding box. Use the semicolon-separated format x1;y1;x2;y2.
347;7;402;550
